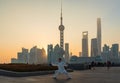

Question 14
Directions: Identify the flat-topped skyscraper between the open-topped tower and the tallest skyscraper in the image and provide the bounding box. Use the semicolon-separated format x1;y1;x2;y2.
91;38;98;57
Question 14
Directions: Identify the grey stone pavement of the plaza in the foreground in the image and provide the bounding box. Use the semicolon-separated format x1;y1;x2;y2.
0;67;120;83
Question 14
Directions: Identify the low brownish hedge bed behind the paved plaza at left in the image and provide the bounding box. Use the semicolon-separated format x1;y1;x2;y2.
0;64;58;72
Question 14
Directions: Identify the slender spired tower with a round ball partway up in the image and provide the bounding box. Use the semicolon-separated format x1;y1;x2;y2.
59;3;65;49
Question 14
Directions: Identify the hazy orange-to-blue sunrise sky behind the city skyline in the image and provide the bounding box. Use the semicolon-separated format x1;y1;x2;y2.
0;0;120;63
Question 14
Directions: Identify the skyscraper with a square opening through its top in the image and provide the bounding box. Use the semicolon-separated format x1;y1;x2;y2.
82;31;88;57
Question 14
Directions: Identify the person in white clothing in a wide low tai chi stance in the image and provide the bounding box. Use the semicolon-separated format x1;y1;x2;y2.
53;58;71;79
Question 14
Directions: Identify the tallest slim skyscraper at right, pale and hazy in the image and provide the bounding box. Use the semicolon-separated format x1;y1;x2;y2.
97;18;102;55
